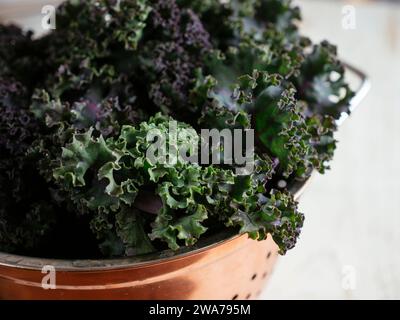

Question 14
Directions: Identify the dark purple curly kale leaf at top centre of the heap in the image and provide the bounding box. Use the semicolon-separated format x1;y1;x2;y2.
138;0;211;118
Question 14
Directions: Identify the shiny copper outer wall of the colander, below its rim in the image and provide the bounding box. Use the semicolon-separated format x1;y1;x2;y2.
0;235;277;299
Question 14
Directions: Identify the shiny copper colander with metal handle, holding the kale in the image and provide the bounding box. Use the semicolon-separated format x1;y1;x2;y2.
0;65;370;300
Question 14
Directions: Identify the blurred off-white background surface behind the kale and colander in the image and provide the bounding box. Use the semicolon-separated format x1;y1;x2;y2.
0;0;400;299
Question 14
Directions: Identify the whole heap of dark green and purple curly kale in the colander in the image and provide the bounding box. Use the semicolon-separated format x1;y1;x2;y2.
0;0;353;258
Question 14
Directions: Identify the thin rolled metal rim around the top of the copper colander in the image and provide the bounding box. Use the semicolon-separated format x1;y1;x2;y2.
0;176;312;272
